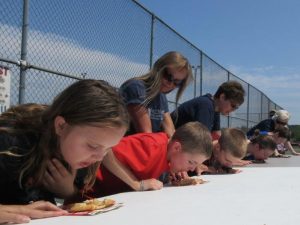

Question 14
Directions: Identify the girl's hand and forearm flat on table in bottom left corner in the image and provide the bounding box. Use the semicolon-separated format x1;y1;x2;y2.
0;201;68;224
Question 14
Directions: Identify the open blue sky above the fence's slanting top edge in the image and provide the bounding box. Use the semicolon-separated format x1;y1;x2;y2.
138;0;300;124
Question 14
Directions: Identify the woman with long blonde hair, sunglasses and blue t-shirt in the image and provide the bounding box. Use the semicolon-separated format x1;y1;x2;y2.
120;52;192;137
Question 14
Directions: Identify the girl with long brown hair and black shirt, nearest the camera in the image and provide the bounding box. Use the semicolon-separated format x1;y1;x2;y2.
0;80;129;208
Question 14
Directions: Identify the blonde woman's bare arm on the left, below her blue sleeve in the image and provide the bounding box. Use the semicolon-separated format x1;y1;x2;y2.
127;104;152;133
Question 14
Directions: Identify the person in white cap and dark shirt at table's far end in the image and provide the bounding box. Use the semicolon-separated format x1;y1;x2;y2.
247;110;300;155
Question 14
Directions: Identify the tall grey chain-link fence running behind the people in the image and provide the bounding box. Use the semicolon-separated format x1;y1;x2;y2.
0;0;281;130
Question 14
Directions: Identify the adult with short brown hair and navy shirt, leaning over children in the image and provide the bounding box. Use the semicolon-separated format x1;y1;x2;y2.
171;81;245;139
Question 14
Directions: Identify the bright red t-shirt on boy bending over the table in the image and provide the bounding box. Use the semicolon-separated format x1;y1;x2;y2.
89;133;169;197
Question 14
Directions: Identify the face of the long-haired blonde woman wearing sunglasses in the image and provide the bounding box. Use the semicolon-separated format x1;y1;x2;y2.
160;67;188;94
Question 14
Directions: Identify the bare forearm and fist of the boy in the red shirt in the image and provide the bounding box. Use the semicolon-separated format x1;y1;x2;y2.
102;151;163;191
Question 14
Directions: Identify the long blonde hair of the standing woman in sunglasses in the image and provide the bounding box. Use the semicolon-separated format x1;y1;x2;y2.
130;52;193;106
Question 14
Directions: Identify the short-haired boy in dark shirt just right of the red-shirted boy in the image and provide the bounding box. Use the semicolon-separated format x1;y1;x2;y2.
196;128;247;175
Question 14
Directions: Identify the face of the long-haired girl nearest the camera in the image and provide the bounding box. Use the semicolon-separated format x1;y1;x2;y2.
55;116;126;169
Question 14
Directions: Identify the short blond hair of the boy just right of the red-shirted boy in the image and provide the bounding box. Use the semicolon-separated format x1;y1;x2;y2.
219;128;247;158
